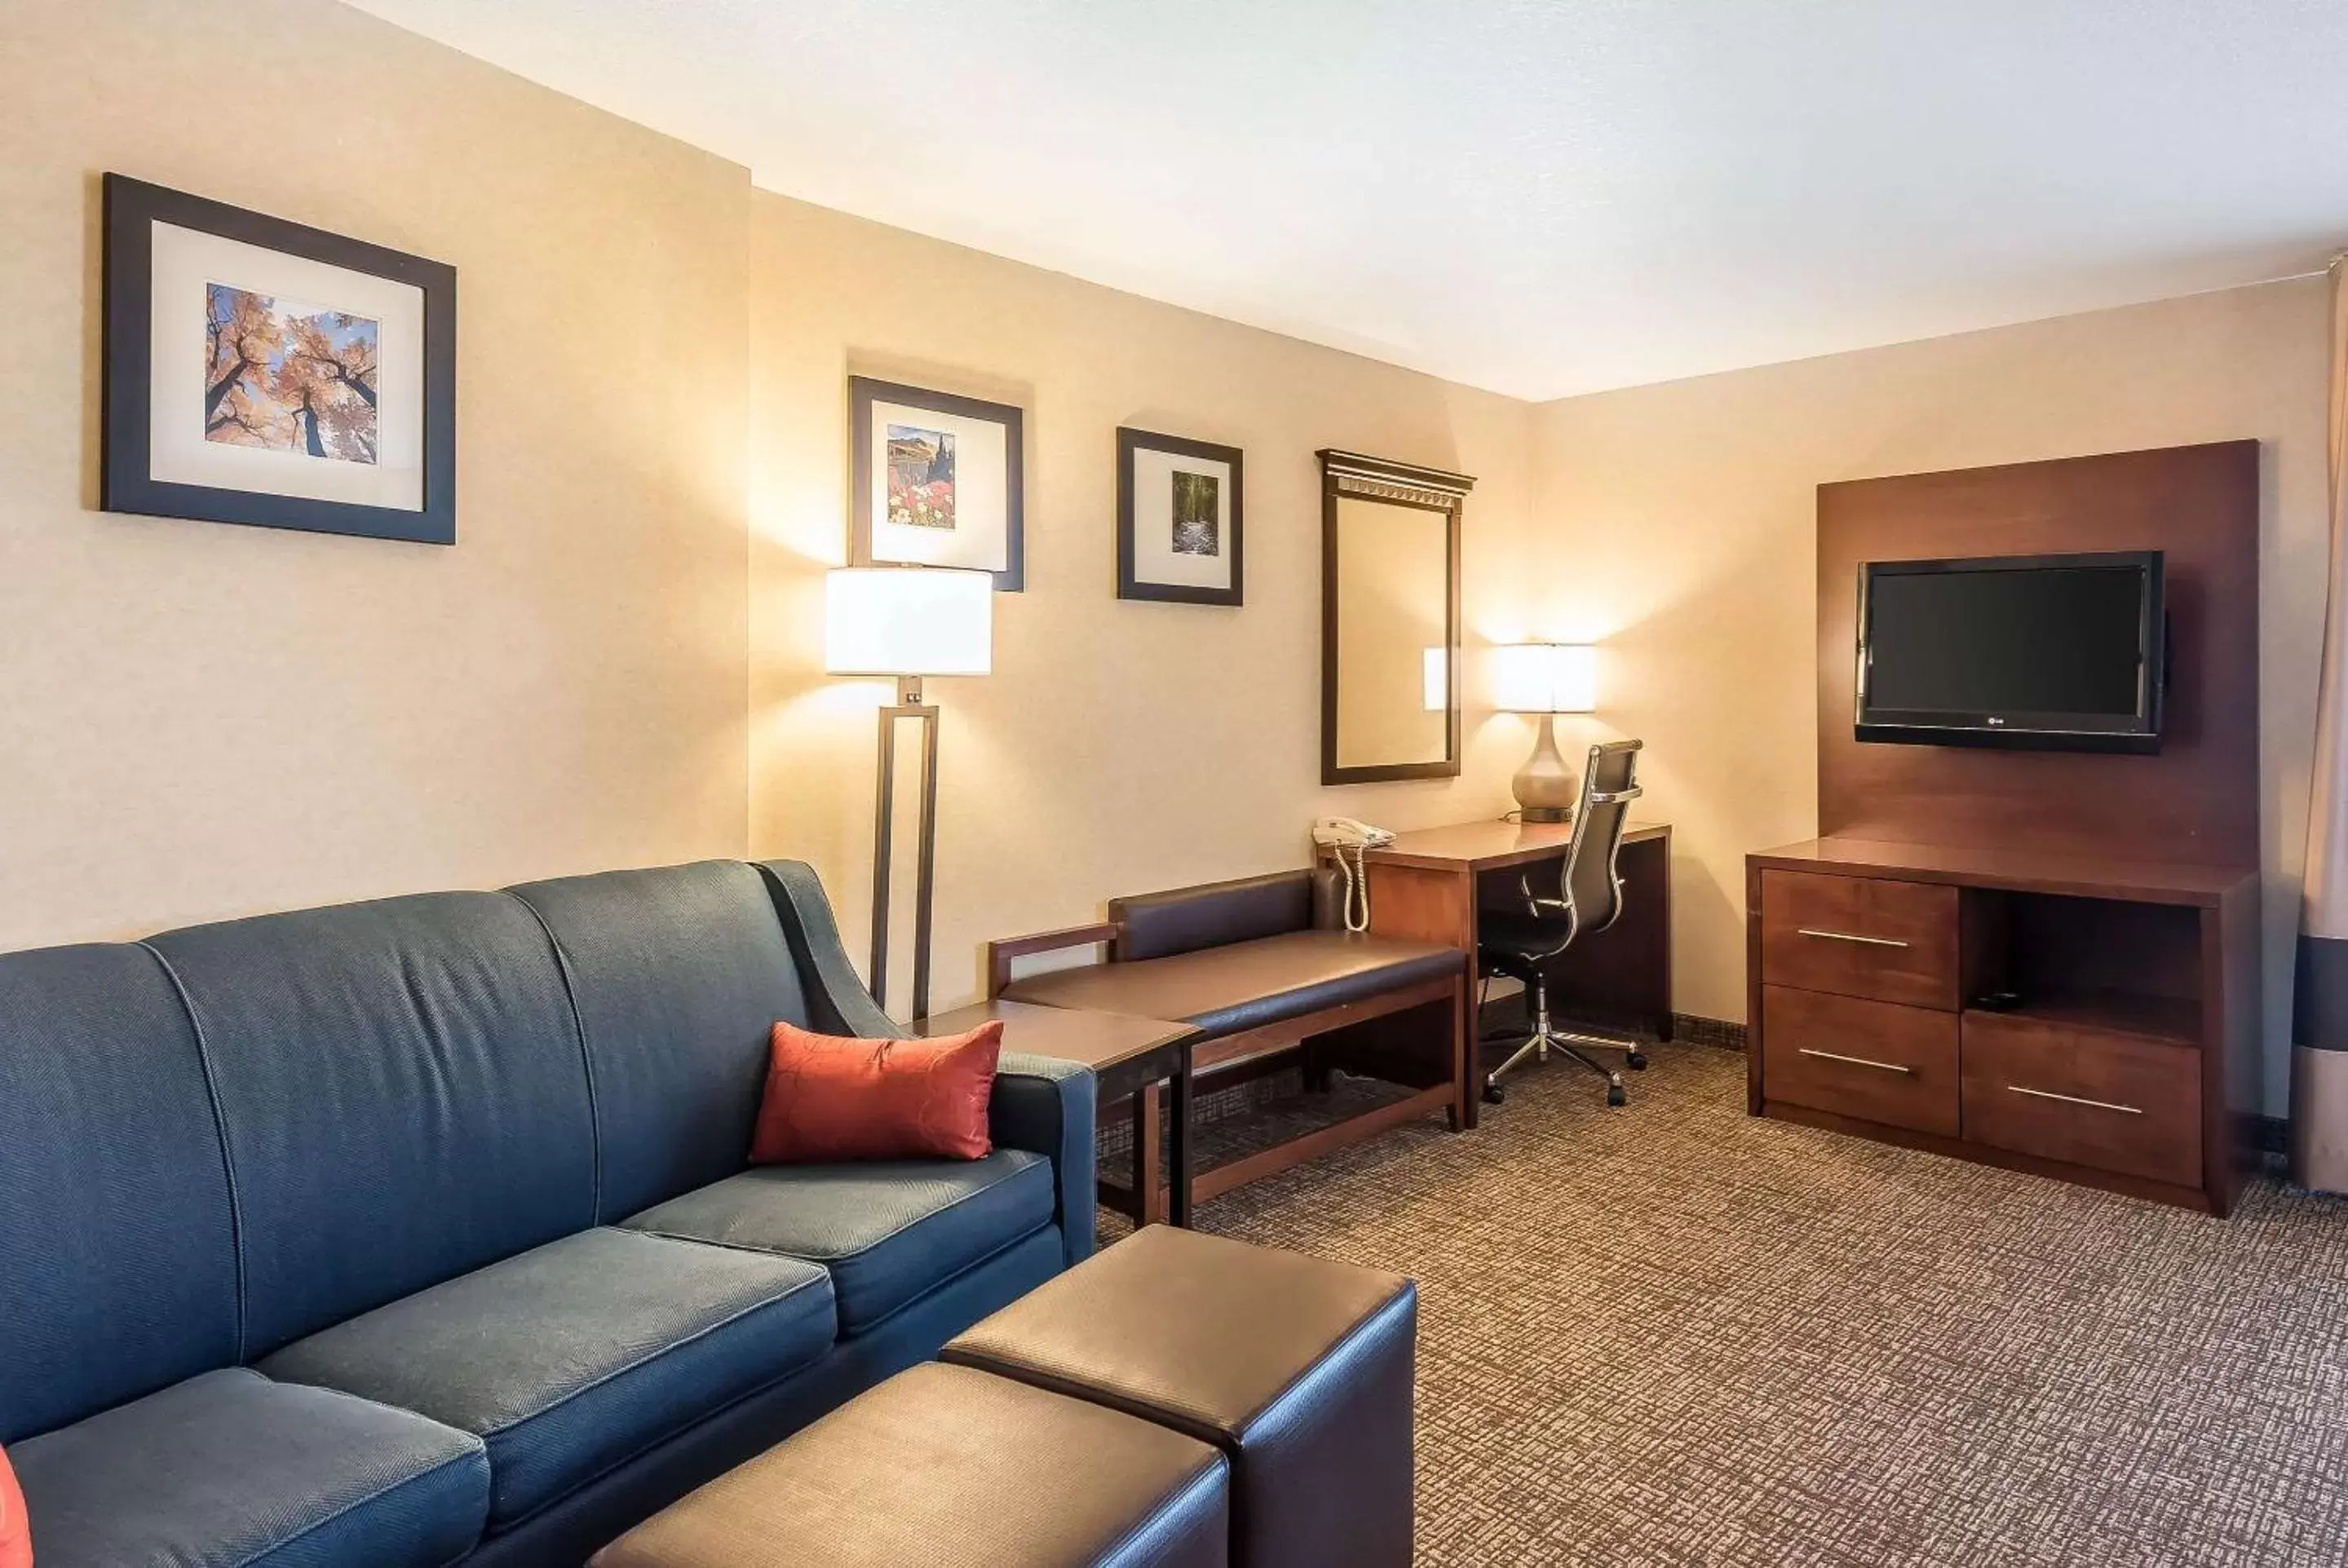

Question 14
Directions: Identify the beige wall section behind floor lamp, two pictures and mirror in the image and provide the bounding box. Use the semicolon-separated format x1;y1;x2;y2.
751;195;1531;1005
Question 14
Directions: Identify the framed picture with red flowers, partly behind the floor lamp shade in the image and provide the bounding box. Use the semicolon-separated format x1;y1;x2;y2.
847;376;1026;594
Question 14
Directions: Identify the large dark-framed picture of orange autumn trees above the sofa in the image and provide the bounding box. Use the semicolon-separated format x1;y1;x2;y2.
99;174;456;545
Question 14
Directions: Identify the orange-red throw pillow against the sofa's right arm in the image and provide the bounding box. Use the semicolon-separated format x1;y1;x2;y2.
749;1021;1002;1164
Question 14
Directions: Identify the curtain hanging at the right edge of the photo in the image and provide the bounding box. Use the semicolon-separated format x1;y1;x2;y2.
2292;256;2348;1192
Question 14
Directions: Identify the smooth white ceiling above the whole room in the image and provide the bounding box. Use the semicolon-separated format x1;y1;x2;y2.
343;0;2348;399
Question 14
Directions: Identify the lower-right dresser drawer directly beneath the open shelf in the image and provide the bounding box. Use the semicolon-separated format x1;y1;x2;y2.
1961;1012;2203;1188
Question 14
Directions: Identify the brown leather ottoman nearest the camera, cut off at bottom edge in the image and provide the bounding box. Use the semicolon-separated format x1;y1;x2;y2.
590;1364;1231;1568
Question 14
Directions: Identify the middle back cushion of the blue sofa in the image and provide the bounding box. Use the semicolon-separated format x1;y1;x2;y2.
150;892;594;1362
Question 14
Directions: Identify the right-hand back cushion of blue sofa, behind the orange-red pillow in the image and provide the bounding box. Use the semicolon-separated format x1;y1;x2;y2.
512;861;807;1223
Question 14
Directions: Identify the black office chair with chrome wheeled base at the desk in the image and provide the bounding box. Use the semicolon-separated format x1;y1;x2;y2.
1477;740;1646;1106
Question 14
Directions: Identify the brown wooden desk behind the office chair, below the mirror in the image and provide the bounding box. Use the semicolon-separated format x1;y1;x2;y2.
1364;817;1672;1040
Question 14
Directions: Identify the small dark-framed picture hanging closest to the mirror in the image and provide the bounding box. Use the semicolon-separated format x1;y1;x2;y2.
1117;427;1245;606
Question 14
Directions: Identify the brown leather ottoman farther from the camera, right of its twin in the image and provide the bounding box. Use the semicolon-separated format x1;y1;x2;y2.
941;1226;1418;1568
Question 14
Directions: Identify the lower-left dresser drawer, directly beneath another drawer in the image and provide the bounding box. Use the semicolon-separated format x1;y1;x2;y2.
1761;986;1958;1138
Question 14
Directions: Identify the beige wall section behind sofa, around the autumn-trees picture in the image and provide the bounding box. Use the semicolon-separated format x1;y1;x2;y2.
0;0;749;948
